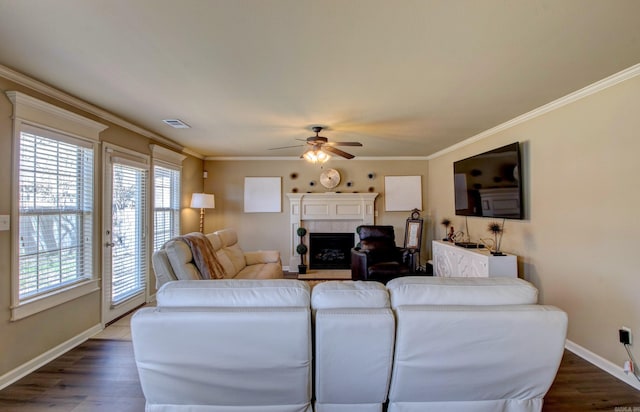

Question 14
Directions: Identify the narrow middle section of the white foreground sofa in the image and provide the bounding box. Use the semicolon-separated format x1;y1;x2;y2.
311;281;395;412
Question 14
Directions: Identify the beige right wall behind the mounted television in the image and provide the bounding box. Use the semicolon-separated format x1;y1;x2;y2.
427;76;640;365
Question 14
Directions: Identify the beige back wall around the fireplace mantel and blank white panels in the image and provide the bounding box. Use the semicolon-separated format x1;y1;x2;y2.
204;158;427;266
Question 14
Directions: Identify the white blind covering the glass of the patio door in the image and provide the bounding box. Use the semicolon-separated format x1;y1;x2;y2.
111;163;147;305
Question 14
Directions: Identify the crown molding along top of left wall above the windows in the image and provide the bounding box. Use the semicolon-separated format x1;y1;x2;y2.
0;64;189;151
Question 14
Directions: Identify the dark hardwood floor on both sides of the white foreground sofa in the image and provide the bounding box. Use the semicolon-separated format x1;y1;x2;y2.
0;339;640;412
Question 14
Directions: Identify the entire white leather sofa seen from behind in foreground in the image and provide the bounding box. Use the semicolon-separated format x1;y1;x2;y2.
132;277;567;412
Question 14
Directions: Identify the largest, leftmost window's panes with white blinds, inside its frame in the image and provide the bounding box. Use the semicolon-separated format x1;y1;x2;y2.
18;128;94;299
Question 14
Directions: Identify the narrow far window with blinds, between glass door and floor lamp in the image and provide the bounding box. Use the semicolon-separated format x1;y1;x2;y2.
153;165;180;251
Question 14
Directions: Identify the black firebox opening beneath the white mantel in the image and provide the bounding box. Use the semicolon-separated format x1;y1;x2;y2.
309;233;354;269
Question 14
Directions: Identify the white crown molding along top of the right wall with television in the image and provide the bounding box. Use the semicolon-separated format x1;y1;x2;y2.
427;63;640;160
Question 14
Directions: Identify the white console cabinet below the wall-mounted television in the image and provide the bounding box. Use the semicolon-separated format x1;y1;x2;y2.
432;240;518;278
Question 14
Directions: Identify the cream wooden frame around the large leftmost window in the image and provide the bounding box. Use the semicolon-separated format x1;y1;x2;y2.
5;91;107;321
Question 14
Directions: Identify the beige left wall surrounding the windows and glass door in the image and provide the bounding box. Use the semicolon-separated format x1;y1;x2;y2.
0;77;202;377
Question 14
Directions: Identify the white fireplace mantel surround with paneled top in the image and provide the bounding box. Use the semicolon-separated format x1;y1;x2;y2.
287;193;378;272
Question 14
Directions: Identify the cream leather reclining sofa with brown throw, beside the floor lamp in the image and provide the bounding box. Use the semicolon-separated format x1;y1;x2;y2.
152;229;283;289
